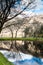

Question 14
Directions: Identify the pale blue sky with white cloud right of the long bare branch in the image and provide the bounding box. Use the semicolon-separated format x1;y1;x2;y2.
17;0;43;16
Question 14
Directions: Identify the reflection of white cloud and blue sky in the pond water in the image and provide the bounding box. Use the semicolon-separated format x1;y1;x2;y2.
0;50;43;65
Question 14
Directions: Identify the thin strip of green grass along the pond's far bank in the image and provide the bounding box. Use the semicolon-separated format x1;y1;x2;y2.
0;37;43;41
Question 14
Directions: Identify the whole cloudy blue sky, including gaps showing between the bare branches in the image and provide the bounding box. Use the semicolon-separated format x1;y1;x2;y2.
8;0;43;18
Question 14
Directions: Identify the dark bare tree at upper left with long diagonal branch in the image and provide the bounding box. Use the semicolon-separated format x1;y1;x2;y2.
0;0;34;32
